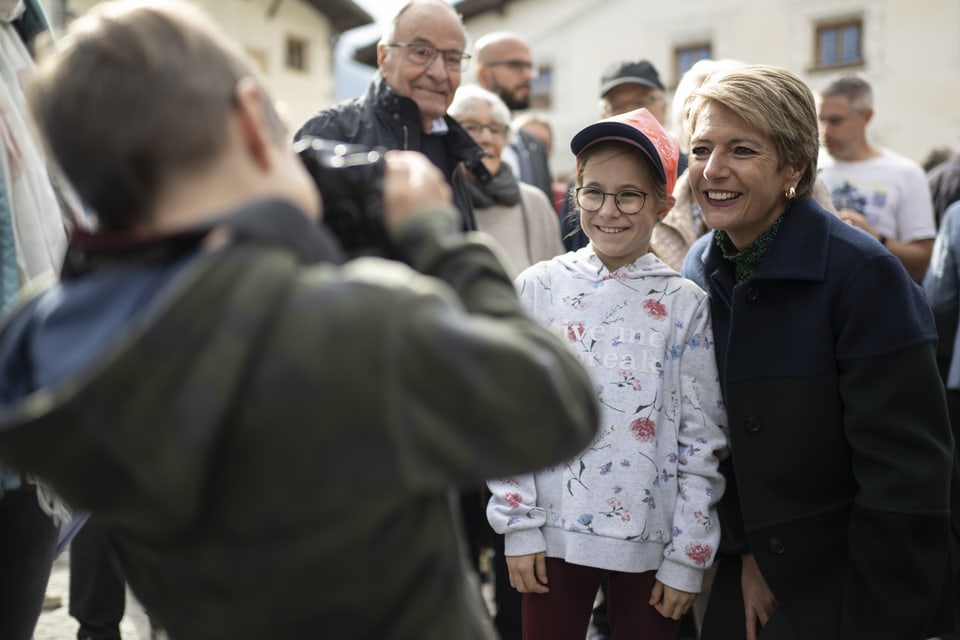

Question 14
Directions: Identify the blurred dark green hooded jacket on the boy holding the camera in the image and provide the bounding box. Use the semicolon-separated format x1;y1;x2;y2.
0;201;598;640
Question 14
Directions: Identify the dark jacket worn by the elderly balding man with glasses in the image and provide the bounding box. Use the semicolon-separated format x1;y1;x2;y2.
294;75;491;231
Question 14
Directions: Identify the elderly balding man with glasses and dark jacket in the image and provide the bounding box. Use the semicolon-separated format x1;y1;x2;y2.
295;0;490;230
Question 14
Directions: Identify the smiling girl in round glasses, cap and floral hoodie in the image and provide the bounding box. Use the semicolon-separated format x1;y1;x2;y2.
487;109;727;640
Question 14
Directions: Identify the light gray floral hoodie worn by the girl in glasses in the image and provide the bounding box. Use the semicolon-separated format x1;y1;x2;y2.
487;246;727;592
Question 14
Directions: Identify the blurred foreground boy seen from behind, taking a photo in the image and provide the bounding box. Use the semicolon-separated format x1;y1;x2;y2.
0;1;597;640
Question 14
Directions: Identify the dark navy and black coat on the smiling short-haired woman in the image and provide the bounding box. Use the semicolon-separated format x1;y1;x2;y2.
684;199;953;640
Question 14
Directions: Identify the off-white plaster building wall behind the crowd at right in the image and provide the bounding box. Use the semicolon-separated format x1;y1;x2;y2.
464;0;960;174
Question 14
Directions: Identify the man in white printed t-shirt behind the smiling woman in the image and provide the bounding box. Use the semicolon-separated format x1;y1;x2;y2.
819;75;937;280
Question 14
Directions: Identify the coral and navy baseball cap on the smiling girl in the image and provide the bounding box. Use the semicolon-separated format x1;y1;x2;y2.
570;108;680;193
